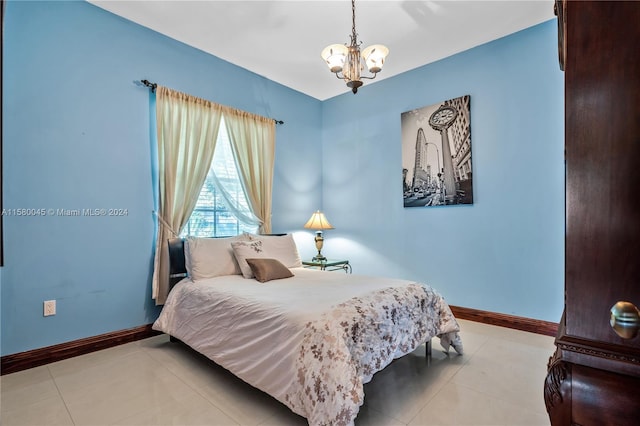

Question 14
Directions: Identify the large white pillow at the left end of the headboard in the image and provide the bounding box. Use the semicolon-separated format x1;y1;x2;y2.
184;234;249;281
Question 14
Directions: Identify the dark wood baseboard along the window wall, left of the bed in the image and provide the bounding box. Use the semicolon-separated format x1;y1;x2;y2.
0;324;161;375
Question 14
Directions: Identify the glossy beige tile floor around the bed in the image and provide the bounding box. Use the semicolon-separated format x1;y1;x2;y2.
0;320;554;426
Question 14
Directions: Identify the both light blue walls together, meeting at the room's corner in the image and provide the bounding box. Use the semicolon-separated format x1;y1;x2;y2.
0;1;564;355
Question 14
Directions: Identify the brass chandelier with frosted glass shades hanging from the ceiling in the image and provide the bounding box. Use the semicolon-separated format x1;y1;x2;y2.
320;0;389;94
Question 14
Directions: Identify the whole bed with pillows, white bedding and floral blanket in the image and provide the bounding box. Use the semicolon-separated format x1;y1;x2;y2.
153;235;462;426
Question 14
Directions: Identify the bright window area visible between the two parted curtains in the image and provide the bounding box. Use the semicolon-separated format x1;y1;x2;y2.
180;117;258;237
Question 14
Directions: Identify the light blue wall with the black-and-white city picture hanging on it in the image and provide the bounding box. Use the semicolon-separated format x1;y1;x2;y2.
322;21;564;322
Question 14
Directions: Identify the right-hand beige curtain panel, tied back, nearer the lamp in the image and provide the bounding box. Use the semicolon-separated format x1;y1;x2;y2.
223;107;276;234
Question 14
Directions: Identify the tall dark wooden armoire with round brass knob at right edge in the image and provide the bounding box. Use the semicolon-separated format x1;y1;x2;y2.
544;0;640;426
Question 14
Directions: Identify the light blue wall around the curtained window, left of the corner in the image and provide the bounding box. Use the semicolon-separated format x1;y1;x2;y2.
1;1;321;355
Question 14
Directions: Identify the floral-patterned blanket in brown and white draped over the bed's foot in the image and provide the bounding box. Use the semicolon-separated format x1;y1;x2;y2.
285;284;462;426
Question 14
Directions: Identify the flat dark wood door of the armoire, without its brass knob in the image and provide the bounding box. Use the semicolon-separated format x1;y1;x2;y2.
564;1;640;371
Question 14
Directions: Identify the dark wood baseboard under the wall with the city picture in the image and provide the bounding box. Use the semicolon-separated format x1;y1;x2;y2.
450;306;558;336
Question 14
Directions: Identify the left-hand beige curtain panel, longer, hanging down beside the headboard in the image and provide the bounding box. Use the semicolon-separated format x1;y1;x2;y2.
153;86;222;305
